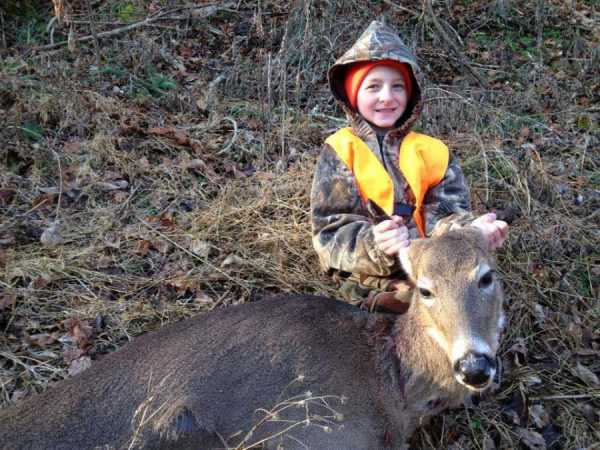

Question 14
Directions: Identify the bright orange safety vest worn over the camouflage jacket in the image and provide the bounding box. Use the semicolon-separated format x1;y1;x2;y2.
325;128;449;237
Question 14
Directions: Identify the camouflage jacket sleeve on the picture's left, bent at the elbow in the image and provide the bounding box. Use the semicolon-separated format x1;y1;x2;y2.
310;145;398;277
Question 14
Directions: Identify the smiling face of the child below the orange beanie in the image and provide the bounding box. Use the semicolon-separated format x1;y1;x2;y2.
356;66;408;128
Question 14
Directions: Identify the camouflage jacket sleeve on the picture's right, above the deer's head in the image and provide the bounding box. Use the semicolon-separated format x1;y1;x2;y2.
409;157;472;238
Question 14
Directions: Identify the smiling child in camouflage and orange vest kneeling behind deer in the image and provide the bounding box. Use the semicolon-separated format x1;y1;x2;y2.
311;22;508;313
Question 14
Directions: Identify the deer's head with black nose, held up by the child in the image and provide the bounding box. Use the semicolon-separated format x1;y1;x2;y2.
400;227;505;391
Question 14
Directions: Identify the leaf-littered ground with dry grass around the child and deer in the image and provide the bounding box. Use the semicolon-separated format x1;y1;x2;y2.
0;0;600;450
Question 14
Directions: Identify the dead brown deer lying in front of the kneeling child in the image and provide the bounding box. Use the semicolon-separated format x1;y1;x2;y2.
0;227;505;450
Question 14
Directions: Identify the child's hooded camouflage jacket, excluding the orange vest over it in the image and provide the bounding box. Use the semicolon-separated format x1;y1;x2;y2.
311;22;470;287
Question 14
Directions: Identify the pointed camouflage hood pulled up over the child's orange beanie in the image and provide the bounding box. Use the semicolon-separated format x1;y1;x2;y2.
327;21;423;129
